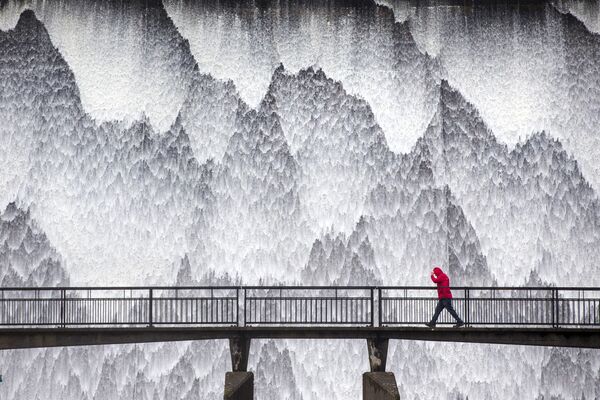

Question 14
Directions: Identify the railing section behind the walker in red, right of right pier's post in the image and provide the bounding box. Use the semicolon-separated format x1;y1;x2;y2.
379;286;600;327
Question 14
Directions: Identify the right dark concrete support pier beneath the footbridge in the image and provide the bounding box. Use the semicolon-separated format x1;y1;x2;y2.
363;338;400;400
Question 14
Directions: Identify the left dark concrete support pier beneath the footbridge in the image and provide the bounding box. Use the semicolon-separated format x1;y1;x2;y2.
223;337;254;400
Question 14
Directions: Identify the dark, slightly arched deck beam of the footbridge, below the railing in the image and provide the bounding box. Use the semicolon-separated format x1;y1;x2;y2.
0;327;600;350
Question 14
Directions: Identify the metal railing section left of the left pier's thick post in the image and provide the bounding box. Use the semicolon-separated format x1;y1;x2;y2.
0;287;239;327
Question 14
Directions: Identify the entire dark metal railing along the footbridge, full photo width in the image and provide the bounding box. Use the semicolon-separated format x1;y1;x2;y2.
0;286;600;328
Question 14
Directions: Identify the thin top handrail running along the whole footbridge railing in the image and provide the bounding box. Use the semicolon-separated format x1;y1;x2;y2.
0;285;600;291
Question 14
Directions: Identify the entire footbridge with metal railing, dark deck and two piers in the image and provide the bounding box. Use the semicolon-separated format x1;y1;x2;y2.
0;286;600;400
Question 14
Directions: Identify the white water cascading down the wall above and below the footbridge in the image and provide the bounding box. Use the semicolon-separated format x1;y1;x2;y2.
0;0;600;400
